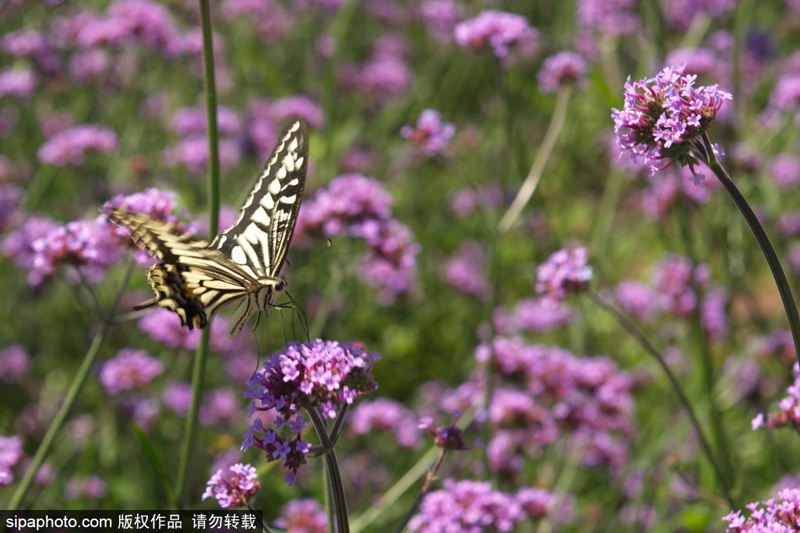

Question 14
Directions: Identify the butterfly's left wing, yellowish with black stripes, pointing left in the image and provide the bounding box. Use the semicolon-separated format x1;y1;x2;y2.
106;209;260;330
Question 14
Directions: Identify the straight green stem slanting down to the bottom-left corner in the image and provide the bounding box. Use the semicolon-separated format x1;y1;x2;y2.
6;261;134;511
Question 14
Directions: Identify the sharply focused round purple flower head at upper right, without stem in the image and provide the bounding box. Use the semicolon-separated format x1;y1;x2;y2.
611;66;732;173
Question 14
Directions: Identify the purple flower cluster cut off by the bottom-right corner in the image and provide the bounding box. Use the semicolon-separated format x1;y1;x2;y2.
722;488;800;533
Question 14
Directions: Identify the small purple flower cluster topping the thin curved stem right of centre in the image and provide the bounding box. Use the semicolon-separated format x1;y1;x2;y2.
536;246;592;301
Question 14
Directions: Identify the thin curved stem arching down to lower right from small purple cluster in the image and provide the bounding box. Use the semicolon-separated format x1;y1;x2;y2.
587;290;737;509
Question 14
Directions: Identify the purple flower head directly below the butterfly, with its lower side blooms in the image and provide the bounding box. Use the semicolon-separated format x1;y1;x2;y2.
242;339;377;484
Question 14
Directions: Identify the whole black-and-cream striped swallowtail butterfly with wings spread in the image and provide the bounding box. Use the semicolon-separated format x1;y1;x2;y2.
106;119;308;337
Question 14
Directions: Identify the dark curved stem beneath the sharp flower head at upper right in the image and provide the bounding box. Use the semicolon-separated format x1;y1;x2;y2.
699;133;800;363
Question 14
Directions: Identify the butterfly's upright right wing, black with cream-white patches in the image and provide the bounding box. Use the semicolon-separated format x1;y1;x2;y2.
211;119;308;281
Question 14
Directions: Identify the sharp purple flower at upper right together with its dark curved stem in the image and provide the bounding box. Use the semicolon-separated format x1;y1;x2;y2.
611;66;800;362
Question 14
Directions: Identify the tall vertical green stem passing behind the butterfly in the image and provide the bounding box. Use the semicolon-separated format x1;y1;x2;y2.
172;0;219;508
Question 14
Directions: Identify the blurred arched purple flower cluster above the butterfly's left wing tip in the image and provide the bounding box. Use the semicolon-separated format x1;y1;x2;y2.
37;124;117;167
